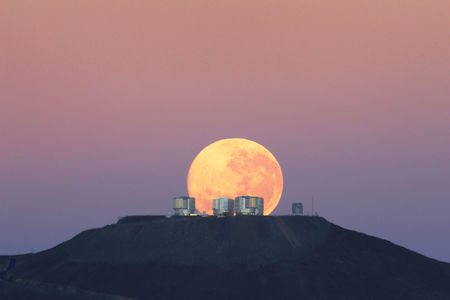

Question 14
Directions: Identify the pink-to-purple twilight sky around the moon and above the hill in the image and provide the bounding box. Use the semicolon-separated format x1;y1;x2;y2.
0;0;450;262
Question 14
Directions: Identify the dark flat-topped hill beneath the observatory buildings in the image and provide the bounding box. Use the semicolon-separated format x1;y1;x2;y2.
0;216;450;299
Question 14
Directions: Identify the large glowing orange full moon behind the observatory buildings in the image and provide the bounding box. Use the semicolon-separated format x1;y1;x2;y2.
187;138;283;215
